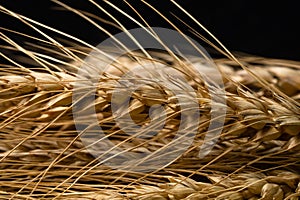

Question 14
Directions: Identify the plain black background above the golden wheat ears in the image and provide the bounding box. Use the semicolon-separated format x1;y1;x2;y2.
0;0;300;60
